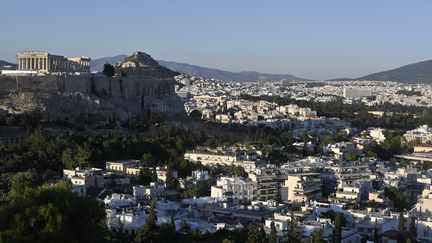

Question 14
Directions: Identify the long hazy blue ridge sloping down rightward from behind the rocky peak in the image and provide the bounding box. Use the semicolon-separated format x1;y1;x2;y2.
158;60;306;82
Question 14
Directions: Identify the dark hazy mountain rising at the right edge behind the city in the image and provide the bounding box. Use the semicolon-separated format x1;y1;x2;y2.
357;60;432;83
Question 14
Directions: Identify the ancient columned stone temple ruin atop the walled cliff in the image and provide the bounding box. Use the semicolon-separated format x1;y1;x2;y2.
17;51;90;73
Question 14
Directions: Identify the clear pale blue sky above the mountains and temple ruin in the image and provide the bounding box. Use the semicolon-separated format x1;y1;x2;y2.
0;0;432;80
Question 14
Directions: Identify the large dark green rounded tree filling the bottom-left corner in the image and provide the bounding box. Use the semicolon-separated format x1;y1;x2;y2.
0;183;108;242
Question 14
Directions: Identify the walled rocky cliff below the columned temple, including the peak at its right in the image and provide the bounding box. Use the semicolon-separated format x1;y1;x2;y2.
0;52;184;119
